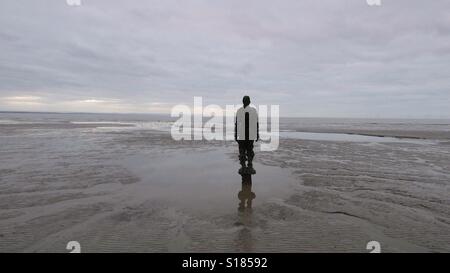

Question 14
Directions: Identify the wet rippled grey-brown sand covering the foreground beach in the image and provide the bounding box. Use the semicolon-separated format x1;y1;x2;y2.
0;118;450;252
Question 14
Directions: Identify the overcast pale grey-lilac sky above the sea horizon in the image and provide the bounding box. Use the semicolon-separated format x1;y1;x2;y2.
0;0;450;118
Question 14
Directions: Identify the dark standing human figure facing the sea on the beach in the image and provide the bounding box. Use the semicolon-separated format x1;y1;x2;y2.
234;96;259;174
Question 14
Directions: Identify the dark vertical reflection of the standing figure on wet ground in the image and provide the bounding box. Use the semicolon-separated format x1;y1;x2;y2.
237;174;256;252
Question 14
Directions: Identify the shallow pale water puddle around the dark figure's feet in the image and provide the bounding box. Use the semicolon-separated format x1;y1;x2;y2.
126;149;297;213
